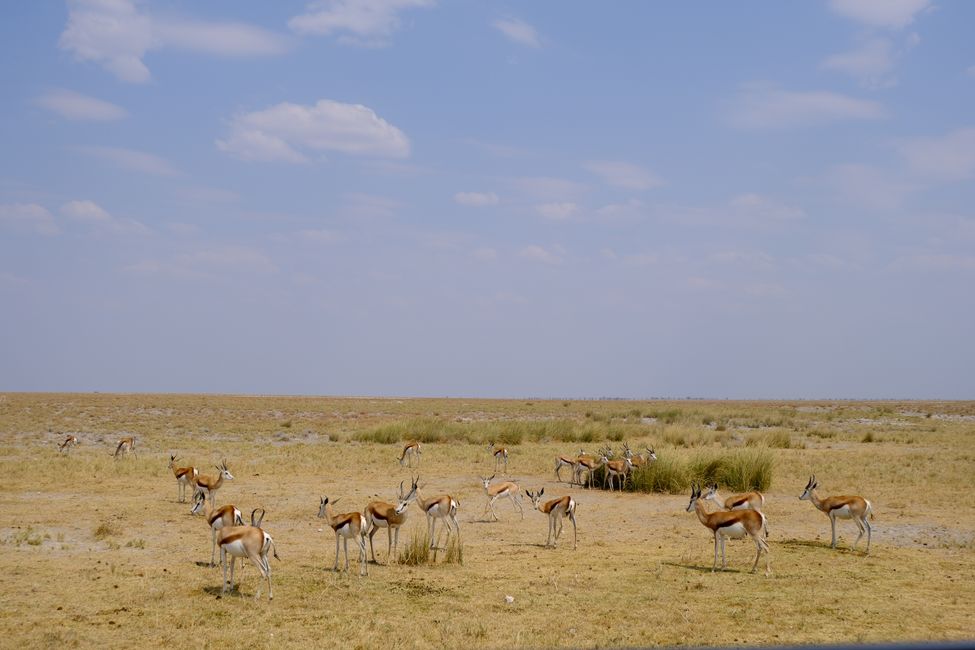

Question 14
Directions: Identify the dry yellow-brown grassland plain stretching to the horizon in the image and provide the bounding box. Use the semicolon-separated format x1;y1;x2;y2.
0;394;975;648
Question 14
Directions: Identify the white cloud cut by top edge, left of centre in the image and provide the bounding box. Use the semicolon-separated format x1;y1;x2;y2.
288;0;434;46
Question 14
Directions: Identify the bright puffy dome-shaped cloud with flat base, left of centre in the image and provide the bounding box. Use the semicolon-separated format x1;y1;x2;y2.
217;99;410;163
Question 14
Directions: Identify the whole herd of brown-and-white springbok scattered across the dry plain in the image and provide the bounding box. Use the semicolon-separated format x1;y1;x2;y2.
65;435;873;600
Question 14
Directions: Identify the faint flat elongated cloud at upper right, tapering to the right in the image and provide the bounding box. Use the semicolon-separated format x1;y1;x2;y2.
729;85;885;129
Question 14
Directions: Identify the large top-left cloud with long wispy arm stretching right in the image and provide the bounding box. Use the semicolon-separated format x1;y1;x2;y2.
58;0;287;83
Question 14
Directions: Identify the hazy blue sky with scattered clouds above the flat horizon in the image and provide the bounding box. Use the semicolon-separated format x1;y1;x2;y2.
0;0;975;399
